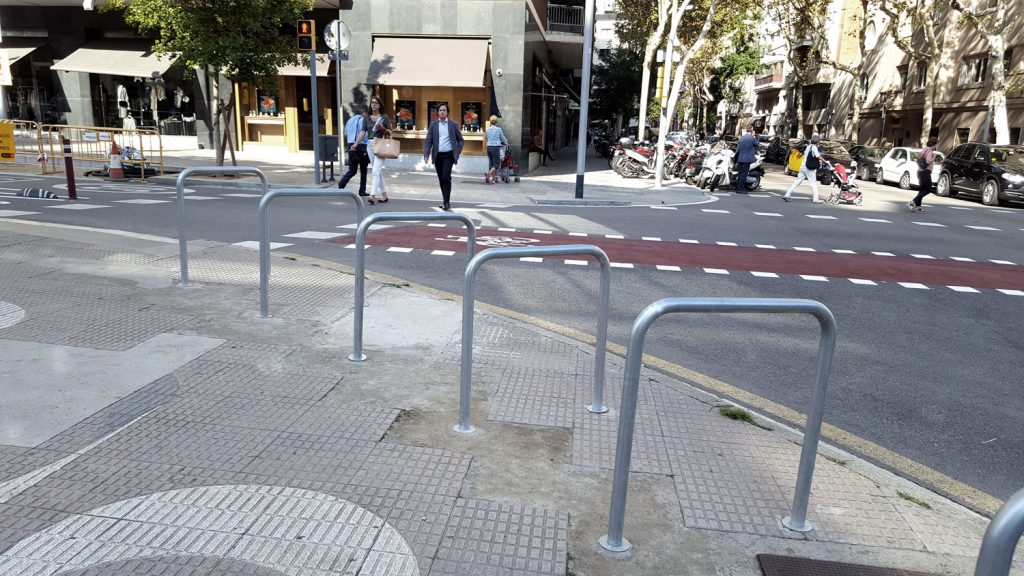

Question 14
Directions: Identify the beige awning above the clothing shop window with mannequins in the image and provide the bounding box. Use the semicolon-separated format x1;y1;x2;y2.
50;40;174;78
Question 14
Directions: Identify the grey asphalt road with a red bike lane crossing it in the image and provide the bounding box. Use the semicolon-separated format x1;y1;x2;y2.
0;163;1024;508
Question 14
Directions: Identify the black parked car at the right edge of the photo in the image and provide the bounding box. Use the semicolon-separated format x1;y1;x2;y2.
935;142;1024;206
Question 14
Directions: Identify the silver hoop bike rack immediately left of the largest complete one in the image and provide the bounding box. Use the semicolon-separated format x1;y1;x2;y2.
454;244;611;434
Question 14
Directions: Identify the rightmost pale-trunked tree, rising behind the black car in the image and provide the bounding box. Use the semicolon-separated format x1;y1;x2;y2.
951;0;1013;145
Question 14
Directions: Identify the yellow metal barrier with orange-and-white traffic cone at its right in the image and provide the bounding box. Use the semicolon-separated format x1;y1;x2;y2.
39;124;164;175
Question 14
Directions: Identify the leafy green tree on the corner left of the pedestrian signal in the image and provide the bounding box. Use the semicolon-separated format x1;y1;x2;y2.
100;0;313;166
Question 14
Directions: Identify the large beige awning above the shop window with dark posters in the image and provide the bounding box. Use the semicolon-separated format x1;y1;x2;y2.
367;37;489;88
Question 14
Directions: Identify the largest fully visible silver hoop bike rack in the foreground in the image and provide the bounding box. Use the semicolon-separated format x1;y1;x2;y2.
598;298;836;552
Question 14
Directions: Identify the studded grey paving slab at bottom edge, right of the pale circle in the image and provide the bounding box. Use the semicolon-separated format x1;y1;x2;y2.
430;498;568;576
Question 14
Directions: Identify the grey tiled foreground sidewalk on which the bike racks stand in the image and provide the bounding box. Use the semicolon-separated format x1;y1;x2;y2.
0;204;1024;576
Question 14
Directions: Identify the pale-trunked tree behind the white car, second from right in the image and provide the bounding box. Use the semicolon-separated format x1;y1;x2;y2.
876;0;949;146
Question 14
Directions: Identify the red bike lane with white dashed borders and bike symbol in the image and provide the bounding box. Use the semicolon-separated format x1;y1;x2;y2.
331;224;1024;289
